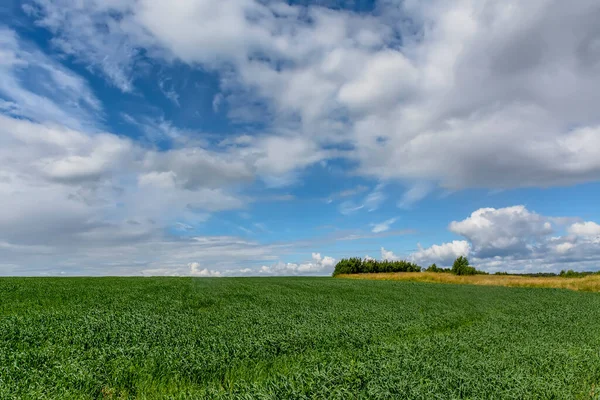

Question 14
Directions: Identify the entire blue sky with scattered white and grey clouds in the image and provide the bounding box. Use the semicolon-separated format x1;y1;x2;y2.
0;0;600;276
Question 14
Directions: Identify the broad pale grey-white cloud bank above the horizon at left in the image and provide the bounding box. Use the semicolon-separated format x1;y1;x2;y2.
0;111;262;275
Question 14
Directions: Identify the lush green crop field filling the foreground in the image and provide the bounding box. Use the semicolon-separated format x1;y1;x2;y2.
0;278;600;399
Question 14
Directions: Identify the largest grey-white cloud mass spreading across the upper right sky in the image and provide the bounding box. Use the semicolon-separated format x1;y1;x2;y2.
23;0;600;191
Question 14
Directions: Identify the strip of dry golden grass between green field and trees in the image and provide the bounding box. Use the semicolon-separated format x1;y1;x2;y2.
337;272;600;292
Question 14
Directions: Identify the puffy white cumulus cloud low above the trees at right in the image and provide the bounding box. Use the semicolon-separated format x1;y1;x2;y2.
410;206;600;272
